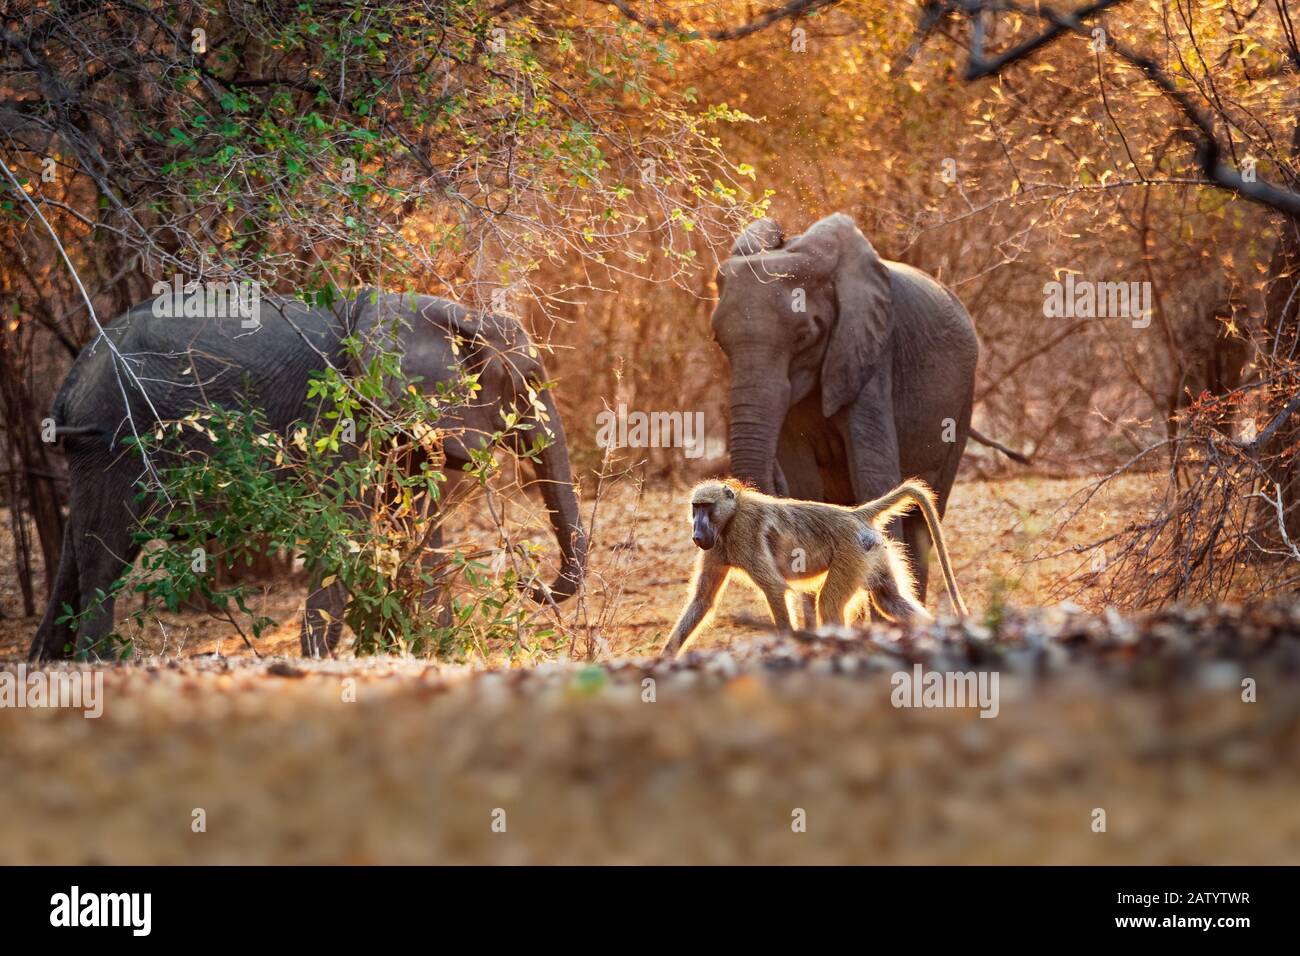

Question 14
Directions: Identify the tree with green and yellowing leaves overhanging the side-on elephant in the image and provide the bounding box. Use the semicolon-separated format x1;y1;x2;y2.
0;0;751;650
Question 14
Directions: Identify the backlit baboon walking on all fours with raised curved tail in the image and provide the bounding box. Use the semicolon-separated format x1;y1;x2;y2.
660;479;966;657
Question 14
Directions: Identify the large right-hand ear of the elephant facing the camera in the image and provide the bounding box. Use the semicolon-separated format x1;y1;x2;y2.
787;212;893;418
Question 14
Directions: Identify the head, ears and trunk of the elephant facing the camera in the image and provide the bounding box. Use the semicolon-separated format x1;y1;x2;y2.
712;213;893;492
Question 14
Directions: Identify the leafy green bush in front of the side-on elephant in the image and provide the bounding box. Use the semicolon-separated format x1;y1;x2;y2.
63;329;554;657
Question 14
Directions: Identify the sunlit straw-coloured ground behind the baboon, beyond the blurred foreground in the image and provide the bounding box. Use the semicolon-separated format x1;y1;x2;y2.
0;475;1161;663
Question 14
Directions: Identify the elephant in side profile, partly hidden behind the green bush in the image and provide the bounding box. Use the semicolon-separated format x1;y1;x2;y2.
30;293;586;659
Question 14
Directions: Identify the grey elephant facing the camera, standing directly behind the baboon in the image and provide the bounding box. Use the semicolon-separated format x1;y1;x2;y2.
712;213;979;598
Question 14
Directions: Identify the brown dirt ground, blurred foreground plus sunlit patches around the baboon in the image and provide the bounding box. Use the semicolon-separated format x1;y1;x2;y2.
0;479;1300;864
